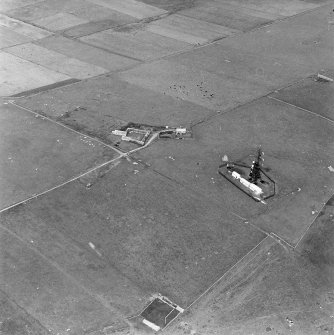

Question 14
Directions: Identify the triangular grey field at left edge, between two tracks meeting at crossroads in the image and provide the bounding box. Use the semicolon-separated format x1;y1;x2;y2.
0;104;115;208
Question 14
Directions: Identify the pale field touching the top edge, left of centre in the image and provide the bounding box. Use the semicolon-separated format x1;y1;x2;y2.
85;0;167;19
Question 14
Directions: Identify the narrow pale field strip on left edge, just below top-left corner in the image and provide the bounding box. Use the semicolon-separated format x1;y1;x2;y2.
0;14;51;40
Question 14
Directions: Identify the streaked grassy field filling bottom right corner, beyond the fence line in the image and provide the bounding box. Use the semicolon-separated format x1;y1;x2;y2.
165;199;334;335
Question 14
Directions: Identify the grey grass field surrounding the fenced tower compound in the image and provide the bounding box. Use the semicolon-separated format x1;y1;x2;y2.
136;98;334;244
